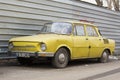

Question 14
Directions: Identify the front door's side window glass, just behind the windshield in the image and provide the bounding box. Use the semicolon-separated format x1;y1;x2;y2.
74;25;85;36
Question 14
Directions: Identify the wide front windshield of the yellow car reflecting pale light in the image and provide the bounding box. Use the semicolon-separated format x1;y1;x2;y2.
41;22;72;34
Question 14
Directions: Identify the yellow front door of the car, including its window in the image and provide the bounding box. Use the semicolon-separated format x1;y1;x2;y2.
73;24;89;58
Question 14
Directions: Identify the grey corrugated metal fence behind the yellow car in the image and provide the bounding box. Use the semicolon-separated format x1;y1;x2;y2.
0;0;120;53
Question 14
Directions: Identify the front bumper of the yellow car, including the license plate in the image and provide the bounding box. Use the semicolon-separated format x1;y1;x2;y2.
10;51;54;57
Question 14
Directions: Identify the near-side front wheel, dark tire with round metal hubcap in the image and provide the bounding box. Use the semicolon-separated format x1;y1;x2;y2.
52;48;69;68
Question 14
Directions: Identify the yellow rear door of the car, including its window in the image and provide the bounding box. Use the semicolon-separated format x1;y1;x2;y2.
86;25;103;58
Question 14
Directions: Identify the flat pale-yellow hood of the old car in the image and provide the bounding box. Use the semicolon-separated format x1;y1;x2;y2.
10;34;67;42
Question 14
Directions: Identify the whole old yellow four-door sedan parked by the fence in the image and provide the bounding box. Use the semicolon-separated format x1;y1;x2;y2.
9;21;115;68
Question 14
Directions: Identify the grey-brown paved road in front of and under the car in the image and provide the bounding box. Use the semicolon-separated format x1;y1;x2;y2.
0;60;120;80
